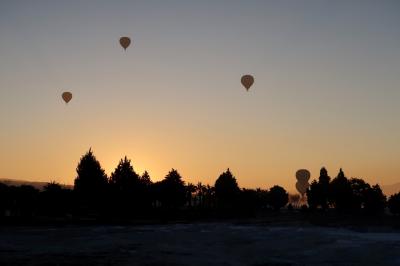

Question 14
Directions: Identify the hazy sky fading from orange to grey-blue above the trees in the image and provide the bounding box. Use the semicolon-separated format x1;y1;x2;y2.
0;0;400;191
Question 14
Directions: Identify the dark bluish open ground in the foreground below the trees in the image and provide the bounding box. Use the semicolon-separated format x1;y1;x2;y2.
0;223;400;266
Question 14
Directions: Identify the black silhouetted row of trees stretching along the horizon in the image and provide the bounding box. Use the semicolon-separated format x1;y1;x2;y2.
0;149;400;219
